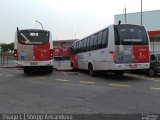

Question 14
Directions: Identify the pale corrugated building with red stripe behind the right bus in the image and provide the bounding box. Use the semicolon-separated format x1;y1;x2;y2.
114;10;160;52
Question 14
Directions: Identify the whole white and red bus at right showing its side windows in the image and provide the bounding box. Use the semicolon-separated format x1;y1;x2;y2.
70;24;150;76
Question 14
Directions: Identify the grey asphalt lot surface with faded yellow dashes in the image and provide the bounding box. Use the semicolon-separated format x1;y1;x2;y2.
0;68;160;114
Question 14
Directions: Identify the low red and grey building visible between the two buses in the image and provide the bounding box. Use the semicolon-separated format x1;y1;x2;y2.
53;39;78;69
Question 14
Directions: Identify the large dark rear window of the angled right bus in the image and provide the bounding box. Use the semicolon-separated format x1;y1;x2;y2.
114;25;148;45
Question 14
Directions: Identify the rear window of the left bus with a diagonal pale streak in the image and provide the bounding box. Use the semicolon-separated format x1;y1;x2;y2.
18;30;49;44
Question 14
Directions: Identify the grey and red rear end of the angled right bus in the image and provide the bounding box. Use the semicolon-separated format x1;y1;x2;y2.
114;24;150;69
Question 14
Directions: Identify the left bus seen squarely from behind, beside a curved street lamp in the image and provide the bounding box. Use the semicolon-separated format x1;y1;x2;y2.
14;28;53;73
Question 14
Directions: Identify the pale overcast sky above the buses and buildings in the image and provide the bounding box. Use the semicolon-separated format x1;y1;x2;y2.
0;0;160;43
